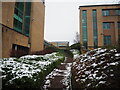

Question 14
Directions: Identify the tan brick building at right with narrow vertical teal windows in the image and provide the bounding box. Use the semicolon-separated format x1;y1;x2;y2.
79;4;120;48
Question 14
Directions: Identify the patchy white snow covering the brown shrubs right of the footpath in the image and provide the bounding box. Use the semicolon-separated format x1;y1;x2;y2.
73;48;120;88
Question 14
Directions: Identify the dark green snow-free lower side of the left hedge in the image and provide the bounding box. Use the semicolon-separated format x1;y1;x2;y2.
2;53;65;90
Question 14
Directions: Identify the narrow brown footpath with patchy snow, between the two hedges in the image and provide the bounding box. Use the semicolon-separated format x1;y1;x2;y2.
43;56;73;90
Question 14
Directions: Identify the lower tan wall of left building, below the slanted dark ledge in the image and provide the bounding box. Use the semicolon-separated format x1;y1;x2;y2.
2;27;28;57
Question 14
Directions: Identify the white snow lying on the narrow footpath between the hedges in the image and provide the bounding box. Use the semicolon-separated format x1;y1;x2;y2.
43;63;72;90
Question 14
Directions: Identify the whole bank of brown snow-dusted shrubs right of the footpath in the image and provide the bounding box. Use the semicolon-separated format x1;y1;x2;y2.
73;48;120;89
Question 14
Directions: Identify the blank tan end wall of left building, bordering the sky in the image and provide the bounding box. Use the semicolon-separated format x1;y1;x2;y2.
30;2;45;52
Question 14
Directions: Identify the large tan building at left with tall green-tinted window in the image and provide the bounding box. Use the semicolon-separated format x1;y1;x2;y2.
0;0;45;57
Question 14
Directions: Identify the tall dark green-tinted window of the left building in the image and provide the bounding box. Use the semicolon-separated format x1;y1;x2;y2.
14;2;31;36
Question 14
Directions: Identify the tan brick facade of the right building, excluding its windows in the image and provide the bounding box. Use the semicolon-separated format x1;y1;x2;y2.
80;6;120;47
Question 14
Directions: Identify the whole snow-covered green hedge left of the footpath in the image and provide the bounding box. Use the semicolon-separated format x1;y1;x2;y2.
0;52;64;89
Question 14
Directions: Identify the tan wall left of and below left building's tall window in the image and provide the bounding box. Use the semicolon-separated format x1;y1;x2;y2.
2;2;28;57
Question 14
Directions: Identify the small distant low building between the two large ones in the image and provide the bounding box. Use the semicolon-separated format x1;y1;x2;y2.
50;41;69;49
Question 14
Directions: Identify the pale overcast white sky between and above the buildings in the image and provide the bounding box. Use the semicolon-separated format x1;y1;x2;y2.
44;0;118;45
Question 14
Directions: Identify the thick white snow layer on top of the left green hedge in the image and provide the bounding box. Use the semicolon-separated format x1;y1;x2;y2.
0;53;63;83
